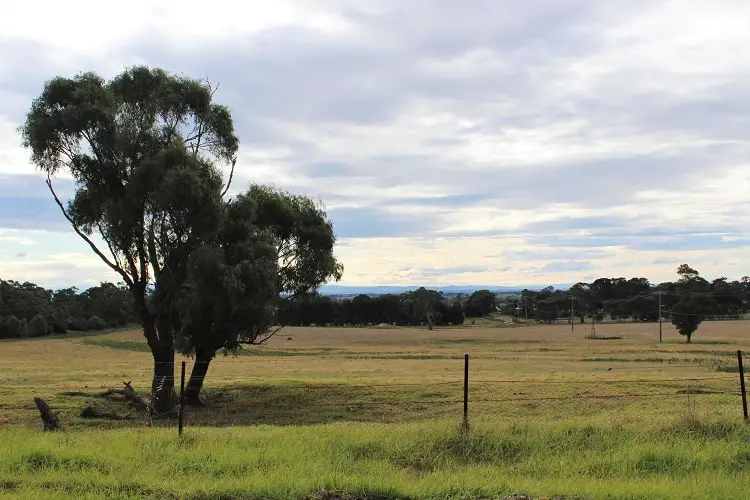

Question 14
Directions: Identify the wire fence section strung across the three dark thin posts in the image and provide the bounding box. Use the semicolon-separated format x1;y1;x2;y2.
178;350;748;434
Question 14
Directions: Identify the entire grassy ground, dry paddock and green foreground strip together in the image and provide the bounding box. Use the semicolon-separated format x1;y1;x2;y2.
0;321;750;498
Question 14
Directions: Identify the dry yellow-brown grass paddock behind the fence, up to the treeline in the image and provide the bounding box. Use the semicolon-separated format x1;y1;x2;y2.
0;321;750;426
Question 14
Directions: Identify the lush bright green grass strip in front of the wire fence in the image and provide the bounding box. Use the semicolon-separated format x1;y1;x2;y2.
0;417;750;499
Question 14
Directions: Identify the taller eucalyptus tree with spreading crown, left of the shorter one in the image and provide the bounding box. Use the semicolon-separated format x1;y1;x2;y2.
20;66;238;416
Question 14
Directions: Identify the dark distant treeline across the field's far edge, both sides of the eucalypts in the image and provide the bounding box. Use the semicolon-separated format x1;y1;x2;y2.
0;265;750;338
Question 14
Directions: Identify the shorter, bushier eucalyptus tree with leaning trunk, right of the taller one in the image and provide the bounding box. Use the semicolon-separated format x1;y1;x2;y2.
177;185;343;405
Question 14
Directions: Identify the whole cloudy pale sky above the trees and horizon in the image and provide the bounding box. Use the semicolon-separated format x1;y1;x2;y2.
0;0;750;287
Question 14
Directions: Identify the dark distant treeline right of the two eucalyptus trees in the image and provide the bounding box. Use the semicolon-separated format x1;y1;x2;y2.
280;265;750;326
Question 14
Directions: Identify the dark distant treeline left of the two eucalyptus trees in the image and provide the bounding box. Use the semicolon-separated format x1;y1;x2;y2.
0;280;138;339
